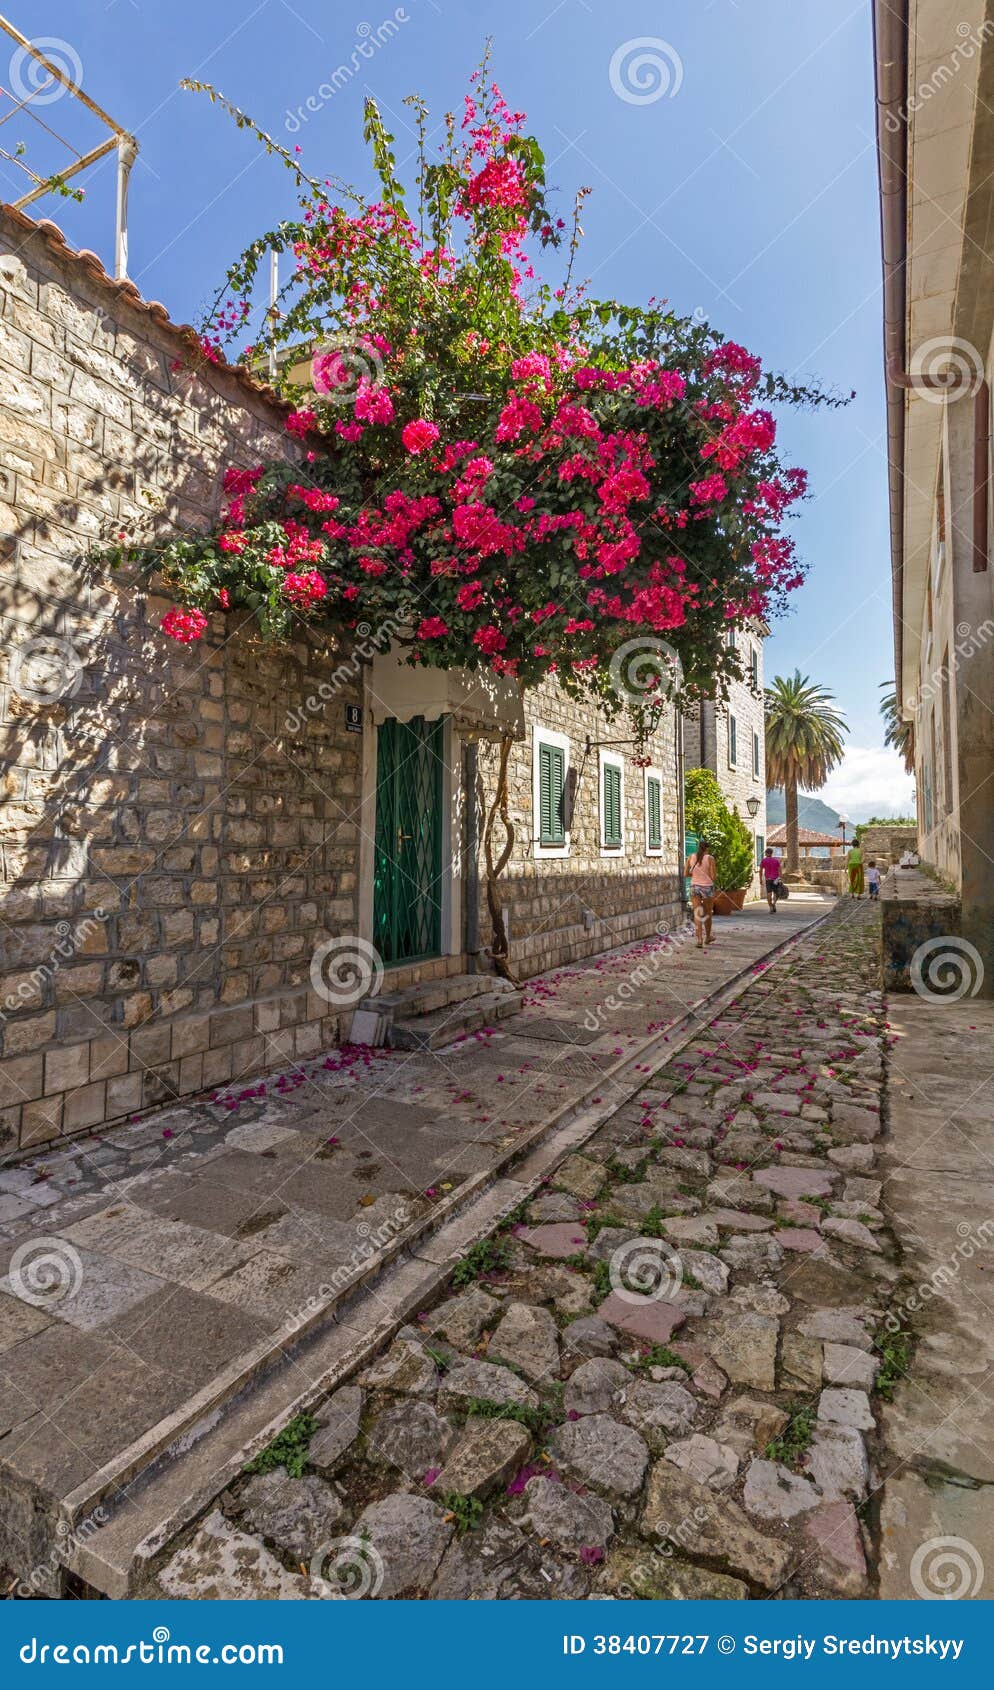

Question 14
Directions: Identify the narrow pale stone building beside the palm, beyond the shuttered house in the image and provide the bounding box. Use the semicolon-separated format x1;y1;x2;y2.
683;624;767;889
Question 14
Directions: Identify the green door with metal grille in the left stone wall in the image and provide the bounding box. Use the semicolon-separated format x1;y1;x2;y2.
374;717;445;967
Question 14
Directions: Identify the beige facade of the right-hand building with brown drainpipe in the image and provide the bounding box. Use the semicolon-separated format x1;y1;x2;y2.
864;0;994;997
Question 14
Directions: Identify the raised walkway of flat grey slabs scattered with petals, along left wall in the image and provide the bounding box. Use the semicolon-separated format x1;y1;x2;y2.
0;899;830;1581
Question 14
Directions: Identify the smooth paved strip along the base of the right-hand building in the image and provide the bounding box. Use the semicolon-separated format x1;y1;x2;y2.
881;986;994;1600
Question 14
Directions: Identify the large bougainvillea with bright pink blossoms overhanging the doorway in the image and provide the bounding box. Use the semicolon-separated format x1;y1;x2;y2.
106;64;835;966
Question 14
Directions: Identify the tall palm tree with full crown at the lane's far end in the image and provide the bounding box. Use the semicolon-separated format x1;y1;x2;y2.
766;669;849;874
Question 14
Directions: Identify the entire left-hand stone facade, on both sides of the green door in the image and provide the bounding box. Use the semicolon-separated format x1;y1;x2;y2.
0;210;681;1154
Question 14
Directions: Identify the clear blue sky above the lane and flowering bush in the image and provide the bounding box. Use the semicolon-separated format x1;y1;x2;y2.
0;0;909;815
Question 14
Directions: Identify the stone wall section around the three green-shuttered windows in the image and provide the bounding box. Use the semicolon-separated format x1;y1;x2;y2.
480;681;683;975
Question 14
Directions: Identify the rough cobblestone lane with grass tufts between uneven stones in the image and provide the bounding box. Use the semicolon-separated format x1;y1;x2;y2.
152;901;901;1599
